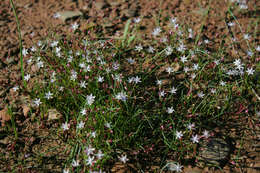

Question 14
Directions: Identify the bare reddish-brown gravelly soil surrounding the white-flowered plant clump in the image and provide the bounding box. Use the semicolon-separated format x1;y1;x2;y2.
0;0;260;173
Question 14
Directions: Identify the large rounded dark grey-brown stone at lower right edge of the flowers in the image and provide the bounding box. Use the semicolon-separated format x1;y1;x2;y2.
199;138;230;166
